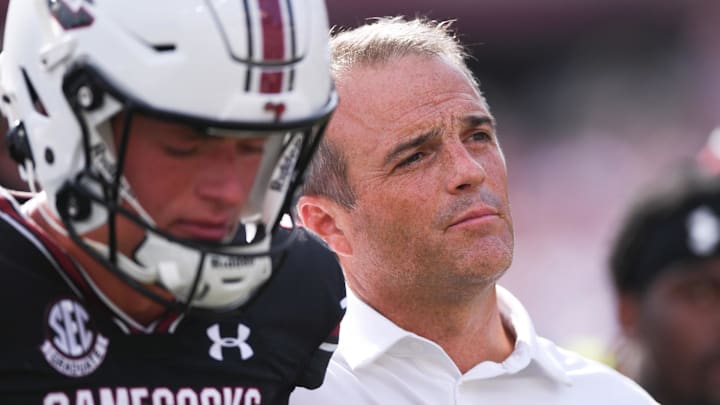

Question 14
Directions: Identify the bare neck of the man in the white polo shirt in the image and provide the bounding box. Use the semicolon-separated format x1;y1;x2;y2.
348;277;515;373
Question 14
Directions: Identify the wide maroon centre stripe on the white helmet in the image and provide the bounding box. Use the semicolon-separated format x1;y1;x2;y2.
258;0;285;93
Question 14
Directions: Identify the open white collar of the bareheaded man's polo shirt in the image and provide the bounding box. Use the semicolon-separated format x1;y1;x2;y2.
338;286;570;384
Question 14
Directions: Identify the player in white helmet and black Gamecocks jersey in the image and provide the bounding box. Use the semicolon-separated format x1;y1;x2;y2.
0;0;345;405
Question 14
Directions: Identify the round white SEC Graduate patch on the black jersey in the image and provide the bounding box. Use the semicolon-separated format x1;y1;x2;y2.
40;298;110;377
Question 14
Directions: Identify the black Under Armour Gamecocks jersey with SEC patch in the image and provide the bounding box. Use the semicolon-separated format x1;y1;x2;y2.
0;189;345;405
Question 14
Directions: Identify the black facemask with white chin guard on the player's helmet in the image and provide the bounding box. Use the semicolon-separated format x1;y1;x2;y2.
40;65;334;310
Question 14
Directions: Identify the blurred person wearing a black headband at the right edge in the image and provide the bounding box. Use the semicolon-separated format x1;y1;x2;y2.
609;162;720;405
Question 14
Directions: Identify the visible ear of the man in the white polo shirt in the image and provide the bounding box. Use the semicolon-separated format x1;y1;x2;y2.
297;195;352;256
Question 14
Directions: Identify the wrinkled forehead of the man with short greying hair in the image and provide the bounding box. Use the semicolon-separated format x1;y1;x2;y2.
327;56;492;151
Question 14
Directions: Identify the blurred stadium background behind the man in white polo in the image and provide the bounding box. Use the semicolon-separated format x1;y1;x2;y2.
0;0;720;355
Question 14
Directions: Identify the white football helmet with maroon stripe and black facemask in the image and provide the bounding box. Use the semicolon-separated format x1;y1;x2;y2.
0;0;337;309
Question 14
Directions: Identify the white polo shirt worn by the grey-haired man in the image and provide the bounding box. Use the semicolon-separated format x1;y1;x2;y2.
290;287;657;405
